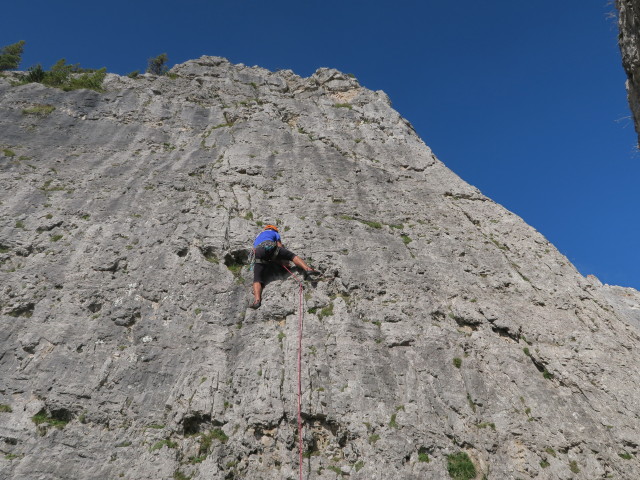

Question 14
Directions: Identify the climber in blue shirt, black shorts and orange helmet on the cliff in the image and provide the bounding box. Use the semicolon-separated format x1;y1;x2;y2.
249;225;320;309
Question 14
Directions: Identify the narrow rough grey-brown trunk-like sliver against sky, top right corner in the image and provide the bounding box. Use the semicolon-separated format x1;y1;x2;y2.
616;0;640;145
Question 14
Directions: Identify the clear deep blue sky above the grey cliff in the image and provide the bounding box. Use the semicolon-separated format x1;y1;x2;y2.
5;0;640;289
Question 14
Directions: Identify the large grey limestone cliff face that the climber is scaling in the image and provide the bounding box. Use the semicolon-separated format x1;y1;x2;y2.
0;57;640;480
